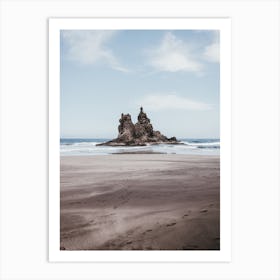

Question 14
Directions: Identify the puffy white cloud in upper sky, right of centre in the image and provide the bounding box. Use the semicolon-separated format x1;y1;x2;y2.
145;32;203;72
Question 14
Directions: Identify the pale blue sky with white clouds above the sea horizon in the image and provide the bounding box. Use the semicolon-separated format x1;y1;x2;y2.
60;30;220;138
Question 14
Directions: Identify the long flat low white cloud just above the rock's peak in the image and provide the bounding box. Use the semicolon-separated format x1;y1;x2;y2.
139;93;212;111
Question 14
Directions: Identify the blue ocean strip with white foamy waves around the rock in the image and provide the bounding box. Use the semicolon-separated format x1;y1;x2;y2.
60;138;220;156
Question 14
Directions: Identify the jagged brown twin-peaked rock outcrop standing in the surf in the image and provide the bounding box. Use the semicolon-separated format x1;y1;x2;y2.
98;107;180;146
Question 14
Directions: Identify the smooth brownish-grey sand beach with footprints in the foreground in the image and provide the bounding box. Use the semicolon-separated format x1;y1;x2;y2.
60;154;220;250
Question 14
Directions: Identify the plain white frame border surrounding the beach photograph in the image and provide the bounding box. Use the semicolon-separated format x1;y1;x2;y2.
49;18;231;262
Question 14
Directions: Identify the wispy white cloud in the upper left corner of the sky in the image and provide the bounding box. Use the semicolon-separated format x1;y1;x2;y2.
62;30;129;72
